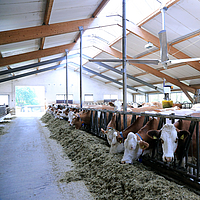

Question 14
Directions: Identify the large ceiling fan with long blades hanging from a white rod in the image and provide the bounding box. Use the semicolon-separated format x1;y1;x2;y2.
89;7;200;69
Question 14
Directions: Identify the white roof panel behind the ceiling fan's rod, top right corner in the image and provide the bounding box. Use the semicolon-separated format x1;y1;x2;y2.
143;0;200;42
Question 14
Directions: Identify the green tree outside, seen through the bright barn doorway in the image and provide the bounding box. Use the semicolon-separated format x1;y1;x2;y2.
15;87;39;107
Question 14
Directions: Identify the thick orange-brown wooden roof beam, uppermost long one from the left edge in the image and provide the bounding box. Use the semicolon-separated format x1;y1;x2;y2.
0;18;116;45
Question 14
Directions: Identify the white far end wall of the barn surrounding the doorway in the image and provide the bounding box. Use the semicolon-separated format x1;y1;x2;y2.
0;68;133;108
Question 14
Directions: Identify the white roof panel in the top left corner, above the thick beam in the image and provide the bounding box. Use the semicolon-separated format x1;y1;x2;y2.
0;0;46;31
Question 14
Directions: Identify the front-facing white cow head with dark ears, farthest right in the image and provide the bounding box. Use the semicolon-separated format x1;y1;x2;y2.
148;124;189;162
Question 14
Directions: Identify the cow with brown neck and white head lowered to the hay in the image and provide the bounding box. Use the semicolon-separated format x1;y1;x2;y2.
121;118;159;164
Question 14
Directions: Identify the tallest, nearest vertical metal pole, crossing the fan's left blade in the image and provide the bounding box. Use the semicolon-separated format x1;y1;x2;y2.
122;0;127;128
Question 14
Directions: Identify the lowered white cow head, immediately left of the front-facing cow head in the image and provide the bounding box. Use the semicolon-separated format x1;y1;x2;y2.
121;132;149;164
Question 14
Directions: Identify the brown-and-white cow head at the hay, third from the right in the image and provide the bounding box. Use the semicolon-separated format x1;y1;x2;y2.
101;127;124;153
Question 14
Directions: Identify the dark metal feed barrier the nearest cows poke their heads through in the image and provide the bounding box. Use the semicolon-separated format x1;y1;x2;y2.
68;108;200;194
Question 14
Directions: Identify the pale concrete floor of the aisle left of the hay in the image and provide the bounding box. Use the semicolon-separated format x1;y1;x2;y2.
0;113;93;200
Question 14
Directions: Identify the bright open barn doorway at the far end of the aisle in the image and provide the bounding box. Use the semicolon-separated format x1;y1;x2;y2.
15;86;45;115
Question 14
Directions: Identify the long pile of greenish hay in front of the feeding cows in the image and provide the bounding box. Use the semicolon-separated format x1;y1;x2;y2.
41;113;200;200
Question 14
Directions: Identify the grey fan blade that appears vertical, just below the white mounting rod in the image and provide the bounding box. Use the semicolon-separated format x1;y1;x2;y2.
158;30;169;62
